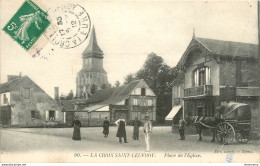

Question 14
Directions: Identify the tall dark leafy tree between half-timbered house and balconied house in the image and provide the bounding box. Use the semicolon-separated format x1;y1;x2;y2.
136;52;178;123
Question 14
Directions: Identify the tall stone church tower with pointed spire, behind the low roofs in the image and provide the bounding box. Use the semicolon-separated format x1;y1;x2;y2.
76;27;108;98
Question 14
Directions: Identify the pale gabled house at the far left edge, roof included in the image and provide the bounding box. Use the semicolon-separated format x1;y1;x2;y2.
0;76;63;126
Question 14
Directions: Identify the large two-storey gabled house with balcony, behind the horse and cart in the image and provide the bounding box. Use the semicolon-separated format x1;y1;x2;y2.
170;36;260;136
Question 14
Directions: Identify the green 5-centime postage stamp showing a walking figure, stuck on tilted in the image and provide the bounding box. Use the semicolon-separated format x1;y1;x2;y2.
3;0;50;51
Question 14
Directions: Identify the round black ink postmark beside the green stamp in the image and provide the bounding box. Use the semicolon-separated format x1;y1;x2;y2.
50;4;91;49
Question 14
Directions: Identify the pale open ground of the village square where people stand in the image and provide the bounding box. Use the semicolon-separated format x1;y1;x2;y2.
0;126;259;162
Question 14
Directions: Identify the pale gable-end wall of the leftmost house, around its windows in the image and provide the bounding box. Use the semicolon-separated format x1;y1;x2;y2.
10;79;63;126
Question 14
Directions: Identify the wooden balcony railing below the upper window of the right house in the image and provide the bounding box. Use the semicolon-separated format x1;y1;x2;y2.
184;85;213;97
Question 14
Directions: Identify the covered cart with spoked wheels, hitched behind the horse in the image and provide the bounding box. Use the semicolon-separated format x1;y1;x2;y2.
215;102;251;144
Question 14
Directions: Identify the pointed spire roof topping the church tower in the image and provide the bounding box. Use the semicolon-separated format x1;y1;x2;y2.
82;26;104;58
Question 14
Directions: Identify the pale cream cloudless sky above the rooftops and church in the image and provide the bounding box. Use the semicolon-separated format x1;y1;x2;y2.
0;0;258;96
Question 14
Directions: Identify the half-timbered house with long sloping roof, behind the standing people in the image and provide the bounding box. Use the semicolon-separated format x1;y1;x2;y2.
75;80;156;126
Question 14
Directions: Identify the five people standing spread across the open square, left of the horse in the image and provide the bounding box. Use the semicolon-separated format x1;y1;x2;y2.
72;116;152;151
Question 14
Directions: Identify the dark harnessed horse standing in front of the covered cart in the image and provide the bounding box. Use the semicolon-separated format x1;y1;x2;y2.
185;106;224;142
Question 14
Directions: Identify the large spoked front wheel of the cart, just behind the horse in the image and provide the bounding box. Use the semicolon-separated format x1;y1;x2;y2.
216;122;235;145
